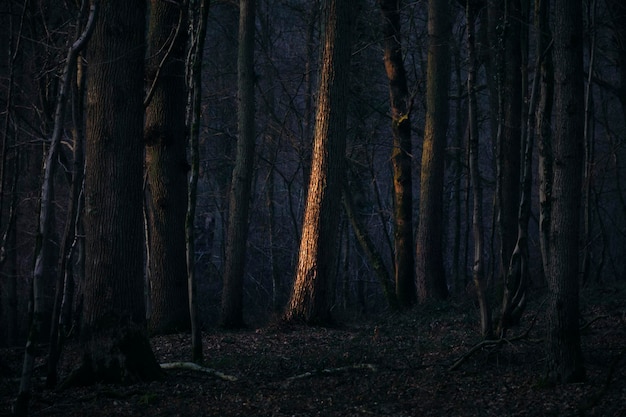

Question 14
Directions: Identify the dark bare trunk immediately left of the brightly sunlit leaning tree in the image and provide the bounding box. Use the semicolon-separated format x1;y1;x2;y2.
220;0;256;327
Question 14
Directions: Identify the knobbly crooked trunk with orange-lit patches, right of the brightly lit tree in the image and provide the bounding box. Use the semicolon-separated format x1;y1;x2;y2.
379;0;416;308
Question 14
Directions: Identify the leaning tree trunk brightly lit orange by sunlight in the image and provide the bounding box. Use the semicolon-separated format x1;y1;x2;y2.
285;0;354;323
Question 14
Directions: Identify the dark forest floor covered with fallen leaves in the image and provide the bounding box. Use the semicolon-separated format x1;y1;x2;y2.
0;286;626;417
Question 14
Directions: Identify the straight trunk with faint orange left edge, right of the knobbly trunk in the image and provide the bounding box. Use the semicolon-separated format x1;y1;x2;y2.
415;0;450;301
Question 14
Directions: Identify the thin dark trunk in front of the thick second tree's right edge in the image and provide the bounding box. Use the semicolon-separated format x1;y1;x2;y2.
185;0;209;363
